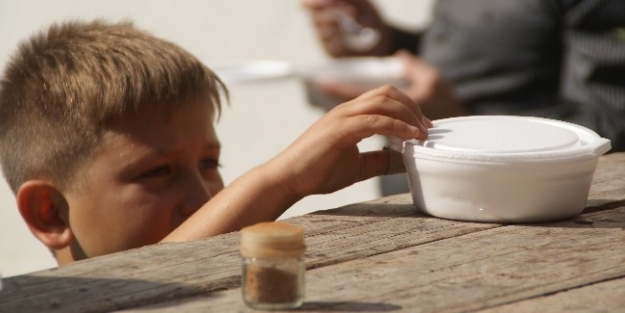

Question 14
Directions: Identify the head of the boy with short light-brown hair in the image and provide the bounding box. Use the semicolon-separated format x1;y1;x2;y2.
0;21;227;263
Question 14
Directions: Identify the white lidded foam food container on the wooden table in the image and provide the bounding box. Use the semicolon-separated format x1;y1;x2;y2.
391;116;611;223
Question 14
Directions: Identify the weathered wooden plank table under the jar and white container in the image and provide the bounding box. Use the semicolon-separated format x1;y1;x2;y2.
0;154;625;312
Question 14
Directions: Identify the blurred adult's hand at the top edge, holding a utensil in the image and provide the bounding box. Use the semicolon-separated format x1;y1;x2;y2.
301;0;391;57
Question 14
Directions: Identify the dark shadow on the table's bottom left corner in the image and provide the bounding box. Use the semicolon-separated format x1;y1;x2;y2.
0;272;222;313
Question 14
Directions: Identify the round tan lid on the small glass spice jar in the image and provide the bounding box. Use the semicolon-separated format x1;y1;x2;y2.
241;222;306;258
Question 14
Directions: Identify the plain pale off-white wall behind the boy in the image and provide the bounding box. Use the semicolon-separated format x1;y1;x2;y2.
0;0;434;277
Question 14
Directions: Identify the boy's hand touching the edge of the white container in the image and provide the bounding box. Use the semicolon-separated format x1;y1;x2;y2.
270;86;432;198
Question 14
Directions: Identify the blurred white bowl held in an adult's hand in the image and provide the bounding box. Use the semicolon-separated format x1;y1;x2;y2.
299;57;406;109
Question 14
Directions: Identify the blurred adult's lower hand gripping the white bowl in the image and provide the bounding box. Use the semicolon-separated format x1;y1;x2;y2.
317;51;466;119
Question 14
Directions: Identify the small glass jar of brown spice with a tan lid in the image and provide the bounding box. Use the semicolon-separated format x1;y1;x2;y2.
241;222;306;310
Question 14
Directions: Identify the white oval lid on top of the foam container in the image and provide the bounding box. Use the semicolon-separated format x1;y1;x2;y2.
391;115;611;163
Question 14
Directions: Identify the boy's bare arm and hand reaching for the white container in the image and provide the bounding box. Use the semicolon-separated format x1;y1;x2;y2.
163;86;431;242
